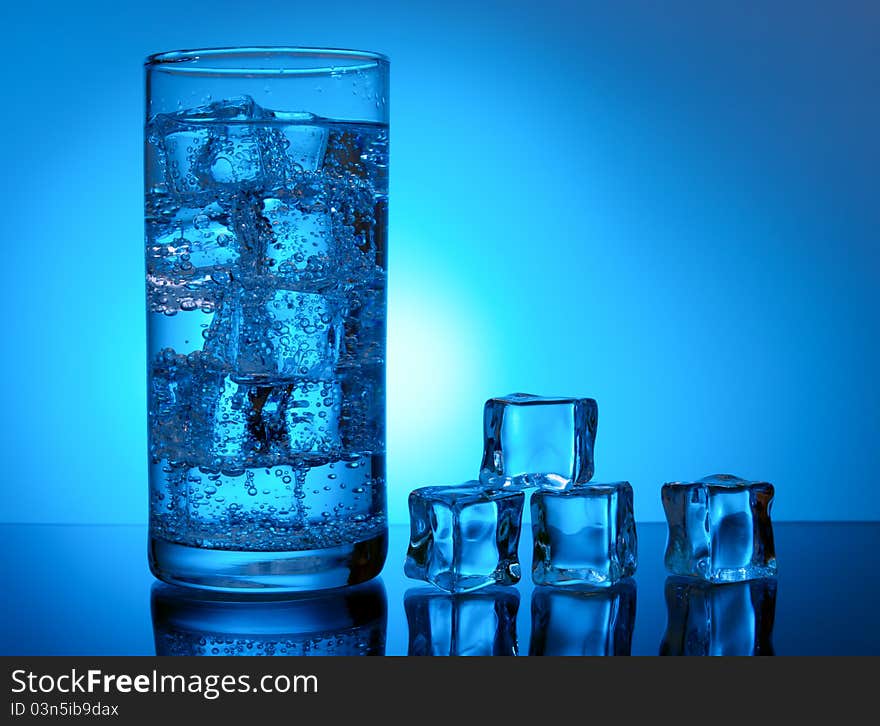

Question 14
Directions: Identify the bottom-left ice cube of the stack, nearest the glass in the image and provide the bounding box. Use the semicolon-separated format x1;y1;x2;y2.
405;481;523;592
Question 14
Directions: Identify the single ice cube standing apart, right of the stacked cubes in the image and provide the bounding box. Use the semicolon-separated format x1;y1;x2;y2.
661;474;776;582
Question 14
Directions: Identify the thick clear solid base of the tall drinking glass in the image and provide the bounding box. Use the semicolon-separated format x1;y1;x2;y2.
149;531;388;592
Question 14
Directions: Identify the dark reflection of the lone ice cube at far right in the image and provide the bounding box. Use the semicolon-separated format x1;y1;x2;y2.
660;577;776;655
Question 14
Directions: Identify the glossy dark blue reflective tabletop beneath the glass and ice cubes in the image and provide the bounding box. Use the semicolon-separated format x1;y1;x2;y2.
0;523;880;655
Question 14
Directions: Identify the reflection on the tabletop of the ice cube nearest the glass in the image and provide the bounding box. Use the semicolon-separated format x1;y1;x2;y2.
403;587;519;656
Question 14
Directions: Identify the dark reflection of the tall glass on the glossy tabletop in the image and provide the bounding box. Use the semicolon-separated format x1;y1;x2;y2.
150;579;388;656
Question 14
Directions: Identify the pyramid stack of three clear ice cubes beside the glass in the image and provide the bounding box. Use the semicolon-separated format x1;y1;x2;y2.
406;393;637;593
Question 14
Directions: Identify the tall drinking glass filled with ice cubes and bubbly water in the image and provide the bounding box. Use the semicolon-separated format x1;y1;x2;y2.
145;48;388;590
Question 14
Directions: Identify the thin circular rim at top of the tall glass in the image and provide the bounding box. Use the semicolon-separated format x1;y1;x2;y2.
144;45;389;78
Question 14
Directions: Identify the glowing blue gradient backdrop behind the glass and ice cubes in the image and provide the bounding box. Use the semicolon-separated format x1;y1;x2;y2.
0;0;880;523
